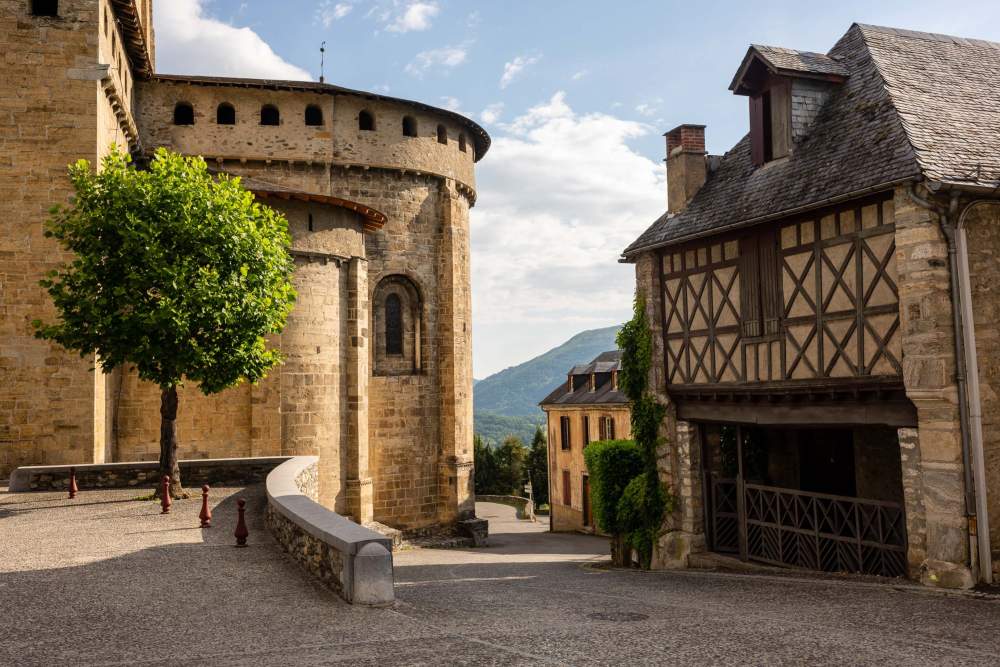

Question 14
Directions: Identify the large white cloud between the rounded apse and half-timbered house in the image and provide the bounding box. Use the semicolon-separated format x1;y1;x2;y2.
472;92;666;377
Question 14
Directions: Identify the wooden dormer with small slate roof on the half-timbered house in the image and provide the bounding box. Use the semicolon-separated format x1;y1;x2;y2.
729;44;848;166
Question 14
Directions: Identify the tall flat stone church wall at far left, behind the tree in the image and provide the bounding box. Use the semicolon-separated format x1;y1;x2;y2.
0;0;124;477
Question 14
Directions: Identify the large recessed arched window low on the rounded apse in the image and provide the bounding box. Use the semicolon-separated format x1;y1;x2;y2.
371;275;426;376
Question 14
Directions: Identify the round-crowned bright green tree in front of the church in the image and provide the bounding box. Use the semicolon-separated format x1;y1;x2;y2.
34;149;295;497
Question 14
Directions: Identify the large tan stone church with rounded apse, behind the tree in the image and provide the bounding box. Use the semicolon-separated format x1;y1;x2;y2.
0;0;490;530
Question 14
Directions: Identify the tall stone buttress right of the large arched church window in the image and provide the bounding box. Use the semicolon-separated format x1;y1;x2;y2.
437;179;476;523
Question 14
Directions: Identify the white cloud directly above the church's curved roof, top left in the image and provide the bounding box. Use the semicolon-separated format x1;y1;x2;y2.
154;0;312;80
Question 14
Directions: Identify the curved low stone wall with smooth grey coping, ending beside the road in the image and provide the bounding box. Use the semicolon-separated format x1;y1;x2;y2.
266;456;395;606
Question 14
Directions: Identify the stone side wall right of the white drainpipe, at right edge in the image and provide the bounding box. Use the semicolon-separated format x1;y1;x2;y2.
966;203;1000;551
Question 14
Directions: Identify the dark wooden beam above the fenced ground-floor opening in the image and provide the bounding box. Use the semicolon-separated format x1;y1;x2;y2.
667;377;917;428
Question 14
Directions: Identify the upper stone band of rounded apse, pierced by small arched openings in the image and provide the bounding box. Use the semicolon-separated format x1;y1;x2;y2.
139;79;476;188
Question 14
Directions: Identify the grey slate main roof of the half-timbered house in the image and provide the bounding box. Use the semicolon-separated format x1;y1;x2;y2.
624;24;1000;258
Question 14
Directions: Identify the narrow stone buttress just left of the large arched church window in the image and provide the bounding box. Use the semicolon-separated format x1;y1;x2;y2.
344;257;374;524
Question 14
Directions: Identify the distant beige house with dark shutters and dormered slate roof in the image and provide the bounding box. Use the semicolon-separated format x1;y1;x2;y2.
540;351;632;532
